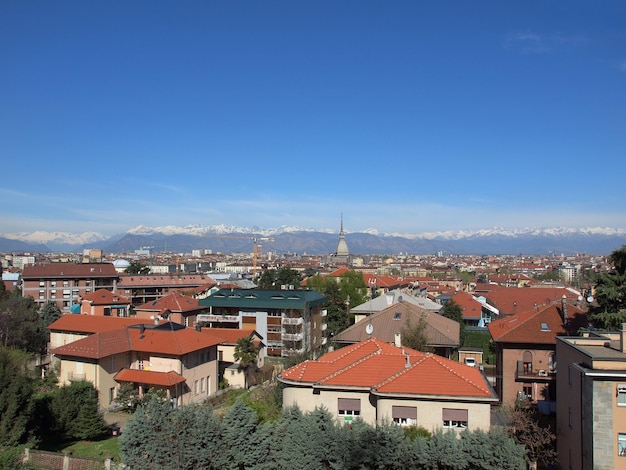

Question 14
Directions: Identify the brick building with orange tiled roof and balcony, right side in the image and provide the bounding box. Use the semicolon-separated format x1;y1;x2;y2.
488;298;586;404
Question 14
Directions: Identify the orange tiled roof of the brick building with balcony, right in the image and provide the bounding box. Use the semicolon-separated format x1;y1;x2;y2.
488;302;585;344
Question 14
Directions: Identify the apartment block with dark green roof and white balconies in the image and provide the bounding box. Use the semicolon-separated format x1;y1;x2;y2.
197;289;326;357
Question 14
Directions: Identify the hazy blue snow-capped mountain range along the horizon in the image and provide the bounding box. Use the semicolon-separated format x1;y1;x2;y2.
0;225;626;255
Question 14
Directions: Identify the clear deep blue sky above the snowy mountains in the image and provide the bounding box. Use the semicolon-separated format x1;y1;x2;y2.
0;0;626;234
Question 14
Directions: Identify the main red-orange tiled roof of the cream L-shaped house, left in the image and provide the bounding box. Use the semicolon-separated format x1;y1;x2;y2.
52;324;222;359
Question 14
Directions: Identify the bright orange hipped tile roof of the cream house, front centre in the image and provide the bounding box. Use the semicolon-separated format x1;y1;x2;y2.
280;338;497;401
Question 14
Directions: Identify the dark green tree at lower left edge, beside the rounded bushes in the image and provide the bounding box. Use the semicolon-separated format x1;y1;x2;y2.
0;347;34;447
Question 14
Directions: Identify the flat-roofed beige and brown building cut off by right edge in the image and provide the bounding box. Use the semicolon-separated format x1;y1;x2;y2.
556;324;626;470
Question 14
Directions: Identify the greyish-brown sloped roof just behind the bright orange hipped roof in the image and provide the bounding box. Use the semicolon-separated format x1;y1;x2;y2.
334;302;461;346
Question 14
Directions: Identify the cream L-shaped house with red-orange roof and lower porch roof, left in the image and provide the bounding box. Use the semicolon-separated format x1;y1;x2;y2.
50;315;221;409
